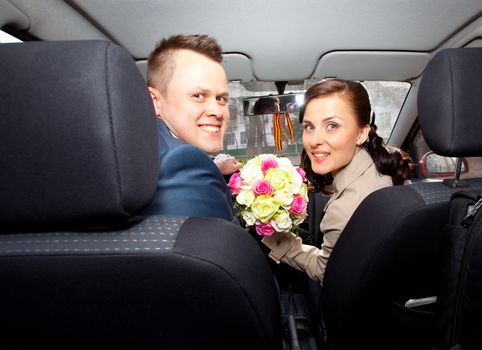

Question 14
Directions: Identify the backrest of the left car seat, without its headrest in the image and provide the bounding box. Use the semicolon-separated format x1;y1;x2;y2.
0;216;281;349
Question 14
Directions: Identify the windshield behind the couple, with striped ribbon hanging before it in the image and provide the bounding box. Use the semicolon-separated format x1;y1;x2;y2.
221;80;410;164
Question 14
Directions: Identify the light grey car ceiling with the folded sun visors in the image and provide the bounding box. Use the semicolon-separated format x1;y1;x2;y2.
0;0;482;81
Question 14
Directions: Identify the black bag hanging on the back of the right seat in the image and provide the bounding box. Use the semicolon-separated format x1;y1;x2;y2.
438;191;482;350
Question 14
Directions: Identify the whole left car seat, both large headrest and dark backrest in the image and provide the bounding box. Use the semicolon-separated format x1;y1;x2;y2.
0;41;282;349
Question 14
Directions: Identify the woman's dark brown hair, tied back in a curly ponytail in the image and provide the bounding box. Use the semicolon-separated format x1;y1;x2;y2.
300;79;411;192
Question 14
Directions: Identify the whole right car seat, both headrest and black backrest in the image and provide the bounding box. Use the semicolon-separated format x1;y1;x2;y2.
322;49;482;349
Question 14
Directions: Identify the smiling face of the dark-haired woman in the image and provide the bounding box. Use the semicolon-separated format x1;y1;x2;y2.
302;94;370;176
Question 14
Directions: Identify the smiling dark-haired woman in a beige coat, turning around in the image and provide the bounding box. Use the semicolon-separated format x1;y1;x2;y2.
262;79;410;283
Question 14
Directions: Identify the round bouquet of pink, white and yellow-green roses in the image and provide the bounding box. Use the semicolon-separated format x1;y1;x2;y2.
228;154;308;236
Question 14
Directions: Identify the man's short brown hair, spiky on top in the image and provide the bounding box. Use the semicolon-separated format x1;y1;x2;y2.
147;34;223;92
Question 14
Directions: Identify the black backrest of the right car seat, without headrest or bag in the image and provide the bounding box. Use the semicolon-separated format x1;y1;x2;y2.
323;179;482;349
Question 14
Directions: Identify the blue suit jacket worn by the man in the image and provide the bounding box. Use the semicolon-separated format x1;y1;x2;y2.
144;119;237;223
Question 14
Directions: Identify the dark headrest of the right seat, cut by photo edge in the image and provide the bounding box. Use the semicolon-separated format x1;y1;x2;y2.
418;48;482;157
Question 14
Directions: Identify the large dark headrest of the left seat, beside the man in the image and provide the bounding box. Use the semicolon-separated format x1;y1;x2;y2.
0;41;159;230
